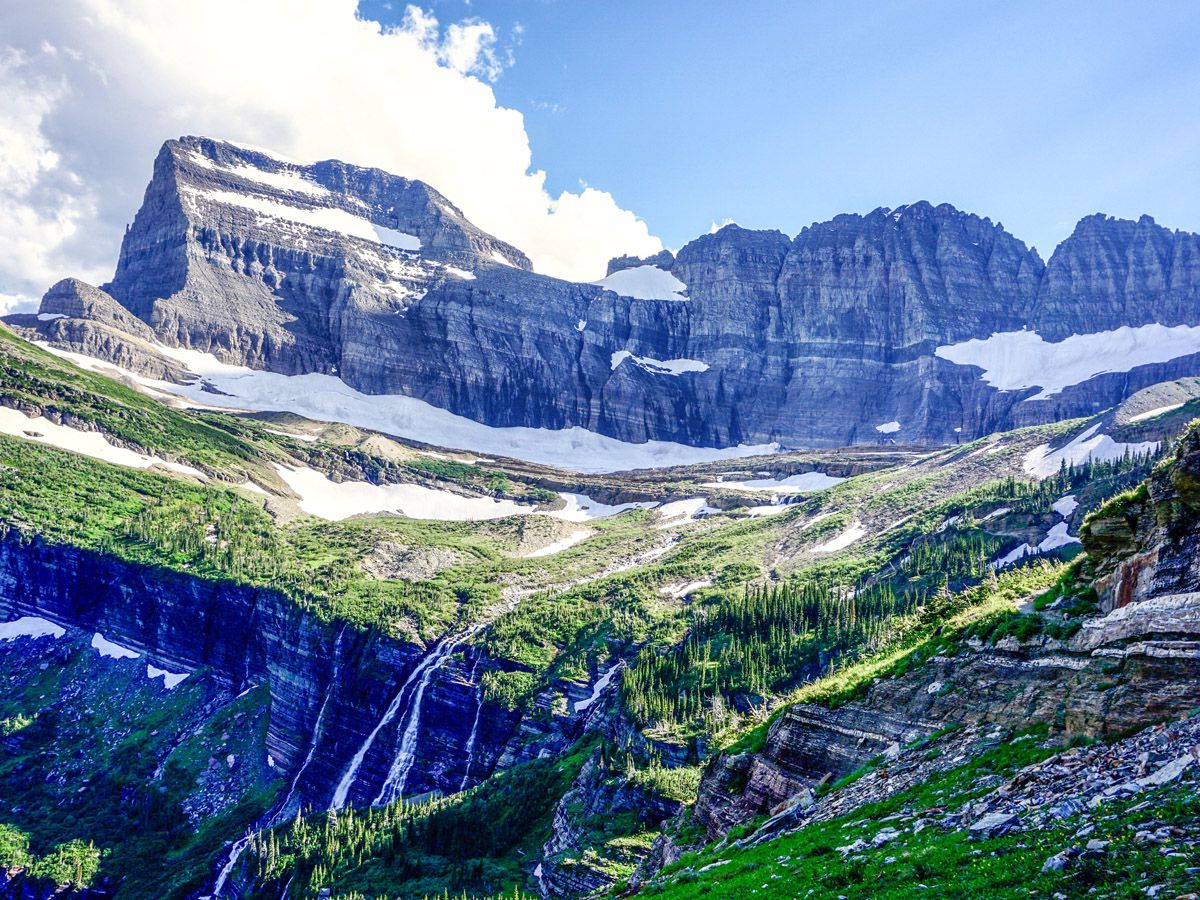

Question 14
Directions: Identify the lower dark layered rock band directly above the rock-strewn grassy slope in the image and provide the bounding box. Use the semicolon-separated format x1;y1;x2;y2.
695;640;1200;840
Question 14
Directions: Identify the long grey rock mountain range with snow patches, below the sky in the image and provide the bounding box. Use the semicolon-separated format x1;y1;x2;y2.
13;138;1200;458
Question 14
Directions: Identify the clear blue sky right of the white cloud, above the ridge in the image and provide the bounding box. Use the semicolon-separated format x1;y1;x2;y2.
360;0;1200;256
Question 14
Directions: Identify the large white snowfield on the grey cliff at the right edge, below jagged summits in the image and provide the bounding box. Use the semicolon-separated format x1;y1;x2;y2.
934;324;1200;400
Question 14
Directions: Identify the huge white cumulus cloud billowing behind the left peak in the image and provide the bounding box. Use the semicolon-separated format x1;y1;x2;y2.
0;0;661;305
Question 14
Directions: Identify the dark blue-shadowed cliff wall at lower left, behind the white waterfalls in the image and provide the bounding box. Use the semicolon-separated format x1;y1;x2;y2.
0;532;540;825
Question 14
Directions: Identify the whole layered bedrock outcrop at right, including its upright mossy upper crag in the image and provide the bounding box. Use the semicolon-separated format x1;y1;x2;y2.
696;430;1200;838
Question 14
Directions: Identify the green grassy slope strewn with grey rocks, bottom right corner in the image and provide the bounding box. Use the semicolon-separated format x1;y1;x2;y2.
635;716;1200;900
